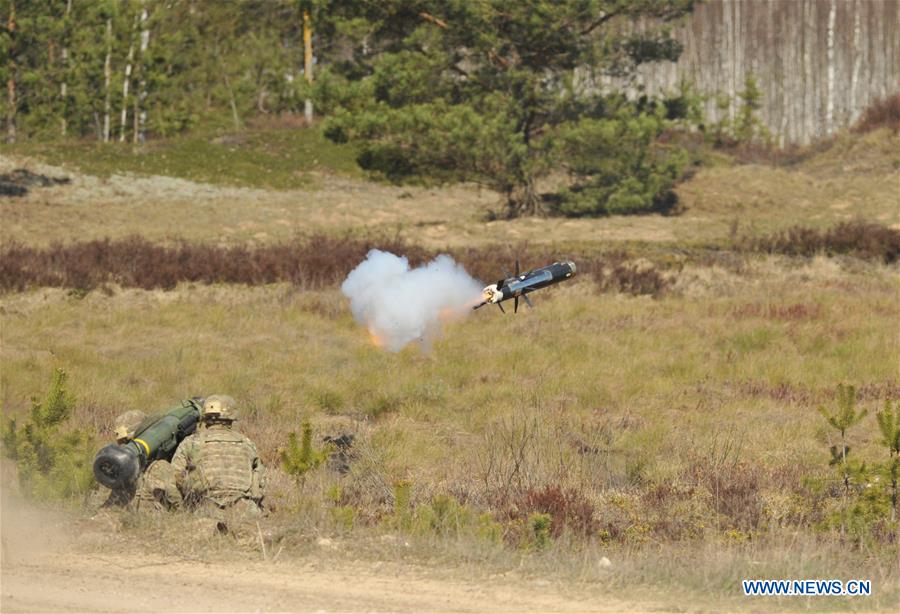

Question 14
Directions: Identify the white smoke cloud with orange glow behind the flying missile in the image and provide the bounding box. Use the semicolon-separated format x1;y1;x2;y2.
341;249;482;352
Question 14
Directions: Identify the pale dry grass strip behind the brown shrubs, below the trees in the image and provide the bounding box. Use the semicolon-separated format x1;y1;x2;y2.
0;130;900;253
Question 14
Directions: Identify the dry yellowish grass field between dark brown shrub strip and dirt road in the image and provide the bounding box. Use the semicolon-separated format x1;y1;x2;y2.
0;258;900;607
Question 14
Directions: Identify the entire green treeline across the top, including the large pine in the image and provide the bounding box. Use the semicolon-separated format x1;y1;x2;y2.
0;0;772;215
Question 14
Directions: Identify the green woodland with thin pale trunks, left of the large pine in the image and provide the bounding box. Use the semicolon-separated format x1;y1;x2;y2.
0;0;318;141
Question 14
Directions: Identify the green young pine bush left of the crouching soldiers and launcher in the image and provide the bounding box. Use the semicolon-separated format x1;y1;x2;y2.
2;369;94;499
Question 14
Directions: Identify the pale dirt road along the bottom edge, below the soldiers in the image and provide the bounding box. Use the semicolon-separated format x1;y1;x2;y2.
0;554;648;612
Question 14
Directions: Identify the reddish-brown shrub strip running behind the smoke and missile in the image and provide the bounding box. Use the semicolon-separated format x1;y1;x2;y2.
0;235;670;298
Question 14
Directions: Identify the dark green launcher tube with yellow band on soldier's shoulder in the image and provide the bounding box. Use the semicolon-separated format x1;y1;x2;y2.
94;397;203;489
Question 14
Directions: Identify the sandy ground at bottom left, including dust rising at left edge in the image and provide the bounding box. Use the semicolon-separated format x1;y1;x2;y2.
0;492;660;613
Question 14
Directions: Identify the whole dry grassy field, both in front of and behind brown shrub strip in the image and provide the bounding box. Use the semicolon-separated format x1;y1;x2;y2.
0;125;900;610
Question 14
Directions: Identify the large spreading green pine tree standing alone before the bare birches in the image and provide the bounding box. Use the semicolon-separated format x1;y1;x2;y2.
319;0;692;215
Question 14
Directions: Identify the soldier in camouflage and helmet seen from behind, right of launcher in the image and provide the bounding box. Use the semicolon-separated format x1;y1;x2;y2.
172;395;265;517
